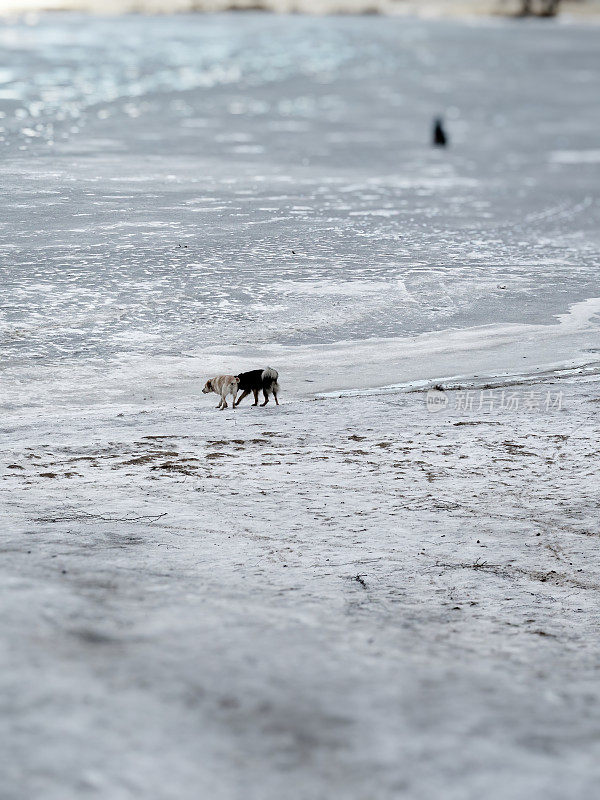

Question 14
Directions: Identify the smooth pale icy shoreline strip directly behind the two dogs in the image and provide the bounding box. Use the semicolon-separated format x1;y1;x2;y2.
0;290;600;412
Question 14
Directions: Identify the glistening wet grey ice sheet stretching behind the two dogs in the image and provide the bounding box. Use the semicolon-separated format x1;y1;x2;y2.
0;14;600;383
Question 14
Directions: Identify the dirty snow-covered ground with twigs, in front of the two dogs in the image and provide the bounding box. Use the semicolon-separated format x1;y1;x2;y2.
1;379;600;800
